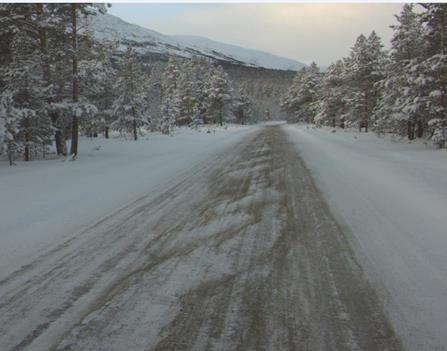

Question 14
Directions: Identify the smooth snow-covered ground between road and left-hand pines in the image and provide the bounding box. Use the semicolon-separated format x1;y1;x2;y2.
0;126;257;279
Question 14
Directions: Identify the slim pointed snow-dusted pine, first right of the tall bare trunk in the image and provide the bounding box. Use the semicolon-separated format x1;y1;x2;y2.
113;47;149;140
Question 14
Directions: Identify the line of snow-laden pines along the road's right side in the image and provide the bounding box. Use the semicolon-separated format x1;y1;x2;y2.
281;3;447;146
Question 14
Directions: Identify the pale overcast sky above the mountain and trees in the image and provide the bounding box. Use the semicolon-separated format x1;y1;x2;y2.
109;3;402;66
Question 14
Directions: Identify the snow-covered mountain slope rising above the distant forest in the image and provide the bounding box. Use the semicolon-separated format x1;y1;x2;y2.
88;14;304;70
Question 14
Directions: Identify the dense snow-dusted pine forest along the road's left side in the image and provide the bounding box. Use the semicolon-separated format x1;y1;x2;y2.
0;3;253;164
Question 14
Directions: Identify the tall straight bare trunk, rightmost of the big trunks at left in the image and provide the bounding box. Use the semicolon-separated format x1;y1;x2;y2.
70;4;79;159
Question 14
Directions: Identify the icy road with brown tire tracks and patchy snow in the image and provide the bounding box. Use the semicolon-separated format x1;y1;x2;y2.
0;126;401;351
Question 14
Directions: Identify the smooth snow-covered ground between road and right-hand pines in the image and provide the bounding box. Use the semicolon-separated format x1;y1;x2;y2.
284;125;447;351
